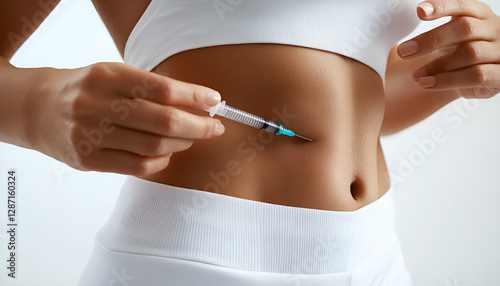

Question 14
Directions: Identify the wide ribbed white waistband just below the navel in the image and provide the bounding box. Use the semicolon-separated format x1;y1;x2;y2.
97;177;399;274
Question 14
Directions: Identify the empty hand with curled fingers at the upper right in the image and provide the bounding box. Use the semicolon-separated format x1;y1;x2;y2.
398;0;500;98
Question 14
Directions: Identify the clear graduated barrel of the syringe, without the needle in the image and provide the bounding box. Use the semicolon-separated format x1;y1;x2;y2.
217;104;283;134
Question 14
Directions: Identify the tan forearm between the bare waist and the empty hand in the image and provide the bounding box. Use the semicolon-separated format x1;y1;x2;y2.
381;45;458;135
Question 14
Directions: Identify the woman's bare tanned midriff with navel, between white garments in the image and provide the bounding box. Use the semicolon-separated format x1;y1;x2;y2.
144;44;390;211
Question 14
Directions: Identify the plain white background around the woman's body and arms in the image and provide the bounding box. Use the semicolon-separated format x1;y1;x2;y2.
0;0;500;286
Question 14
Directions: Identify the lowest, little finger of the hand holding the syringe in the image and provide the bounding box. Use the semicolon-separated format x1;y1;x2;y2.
80;149;171;176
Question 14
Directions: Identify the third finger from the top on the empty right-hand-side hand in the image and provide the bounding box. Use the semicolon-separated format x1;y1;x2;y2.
413;41;500;81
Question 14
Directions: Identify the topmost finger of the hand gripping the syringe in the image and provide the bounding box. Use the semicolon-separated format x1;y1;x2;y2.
117;63;221;109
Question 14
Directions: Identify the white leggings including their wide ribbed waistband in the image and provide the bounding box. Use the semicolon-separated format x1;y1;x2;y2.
77;177;411;286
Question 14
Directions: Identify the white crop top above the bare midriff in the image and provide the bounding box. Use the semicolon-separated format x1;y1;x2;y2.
125;0;421;80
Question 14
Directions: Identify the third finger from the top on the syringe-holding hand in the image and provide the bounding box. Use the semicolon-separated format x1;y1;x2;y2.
100;126;193;156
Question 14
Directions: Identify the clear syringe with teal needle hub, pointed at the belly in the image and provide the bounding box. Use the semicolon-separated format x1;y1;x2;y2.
205;101;314;142
